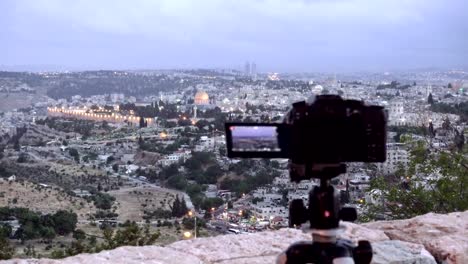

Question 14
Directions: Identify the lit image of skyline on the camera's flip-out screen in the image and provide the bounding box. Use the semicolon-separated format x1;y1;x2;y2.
230;126;281;152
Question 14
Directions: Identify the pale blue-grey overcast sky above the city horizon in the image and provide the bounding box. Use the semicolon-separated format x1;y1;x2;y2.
0;0;468;73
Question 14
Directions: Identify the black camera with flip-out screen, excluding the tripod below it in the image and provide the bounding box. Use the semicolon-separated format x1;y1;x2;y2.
225;95;387;181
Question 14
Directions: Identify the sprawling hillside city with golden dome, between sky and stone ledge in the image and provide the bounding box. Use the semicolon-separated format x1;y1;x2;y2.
0;70;468;257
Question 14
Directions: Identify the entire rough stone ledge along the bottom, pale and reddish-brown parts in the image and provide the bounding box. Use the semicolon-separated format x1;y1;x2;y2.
3;211;468;264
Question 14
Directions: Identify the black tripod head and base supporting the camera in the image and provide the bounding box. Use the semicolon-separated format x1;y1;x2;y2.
277;164;372;264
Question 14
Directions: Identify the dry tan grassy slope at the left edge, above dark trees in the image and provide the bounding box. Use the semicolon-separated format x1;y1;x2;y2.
0;181;96;220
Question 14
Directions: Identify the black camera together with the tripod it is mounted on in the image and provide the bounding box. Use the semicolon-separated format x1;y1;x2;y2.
226;95;387;264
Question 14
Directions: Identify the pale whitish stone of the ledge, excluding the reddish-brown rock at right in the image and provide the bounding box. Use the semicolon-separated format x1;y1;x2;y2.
1;228;435;264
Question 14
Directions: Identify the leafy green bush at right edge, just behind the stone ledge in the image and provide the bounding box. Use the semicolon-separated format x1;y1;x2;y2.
367;142;468;219
